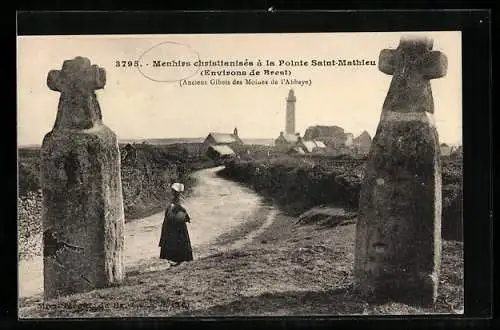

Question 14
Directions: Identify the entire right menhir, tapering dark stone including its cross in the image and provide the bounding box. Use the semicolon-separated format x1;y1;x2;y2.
354;37;447;304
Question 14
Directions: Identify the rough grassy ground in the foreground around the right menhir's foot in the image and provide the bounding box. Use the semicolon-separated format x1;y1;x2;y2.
20;209;463;318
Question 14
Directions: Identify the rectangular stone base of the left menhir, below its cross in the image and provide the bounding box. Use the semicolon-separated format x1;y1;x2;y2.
41;124;124;299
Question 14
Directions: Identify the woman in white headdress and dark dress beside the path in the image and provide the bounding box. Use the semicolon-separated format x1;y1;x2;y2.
159;183;193;266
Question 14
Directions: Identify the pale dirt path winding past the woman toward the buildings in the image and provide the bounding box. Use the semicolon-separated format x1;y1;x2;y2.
19;167;276;297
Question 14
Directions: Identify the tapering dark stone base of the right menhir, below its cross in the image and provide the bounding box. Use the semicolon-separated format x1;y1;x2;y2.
354;111;441;305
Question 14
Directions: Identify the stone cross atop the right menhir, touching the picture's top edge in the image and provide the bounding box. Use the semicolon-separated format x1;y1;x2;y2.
378;36;448;113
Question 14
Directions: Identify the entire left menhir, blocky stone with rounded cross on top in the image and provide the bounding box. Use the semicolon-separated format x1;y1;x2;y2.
41;57;124;299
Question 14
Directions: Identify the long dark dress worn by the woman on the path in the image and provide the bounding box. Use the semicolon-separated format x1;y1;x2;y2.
159;203;193;262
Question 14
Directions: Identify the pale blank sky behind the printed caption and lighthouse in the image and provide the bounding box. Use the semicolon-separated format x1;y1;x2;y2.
17;31;462;145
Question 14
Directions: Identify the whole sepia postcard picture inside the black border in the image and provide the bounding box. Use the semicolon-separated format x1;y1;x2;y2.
17;31;464;319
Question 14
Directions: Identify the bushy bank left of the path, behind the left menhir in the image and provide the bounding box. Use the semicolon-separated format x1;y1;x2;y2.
19;143;213;221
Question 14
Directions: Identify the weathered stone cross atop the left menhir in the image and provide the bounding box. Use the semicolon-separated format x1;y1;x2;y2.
47;57;106;130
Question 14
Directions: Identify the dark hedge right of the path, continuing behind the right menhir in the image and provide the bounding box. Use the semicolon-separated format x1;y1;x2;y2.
220;155;462;240
